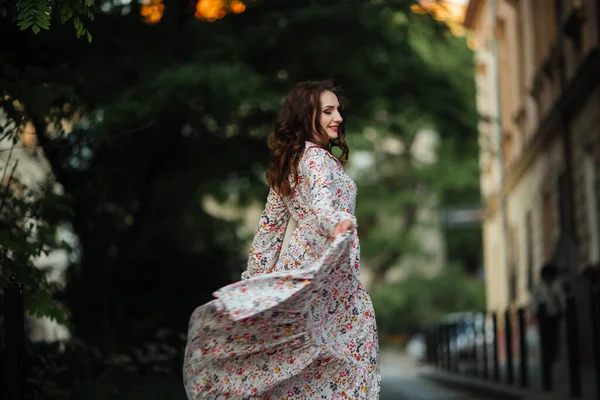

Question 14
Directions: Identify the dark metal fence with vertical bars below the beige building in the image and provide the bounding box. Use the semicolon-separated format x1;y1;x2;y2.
424;288;600;399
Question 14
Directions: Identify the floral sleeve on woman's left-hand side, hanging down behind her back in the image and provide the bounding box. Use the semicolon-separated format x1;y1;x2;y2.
242;188;290;279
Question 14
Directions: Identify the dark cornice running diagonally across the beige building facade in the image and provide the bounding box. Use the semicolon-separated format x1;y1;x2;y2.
502;48;600;195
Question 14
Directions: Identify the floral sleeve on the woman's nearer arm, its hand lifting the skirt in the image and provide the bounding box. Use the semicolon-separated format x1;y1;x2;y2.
300;147;356;237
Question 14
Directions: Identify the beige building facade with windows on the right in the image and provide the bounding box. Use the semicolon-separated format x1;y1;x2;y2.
465;0;600;366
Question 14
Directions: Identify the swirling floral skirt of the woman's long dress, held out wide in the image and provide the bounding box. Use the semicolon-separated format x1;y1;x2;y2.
183;235;380;400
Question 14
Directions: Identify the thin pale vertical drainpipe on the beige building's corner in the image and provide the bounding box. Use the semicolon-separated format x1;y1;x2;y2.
489;0;511;311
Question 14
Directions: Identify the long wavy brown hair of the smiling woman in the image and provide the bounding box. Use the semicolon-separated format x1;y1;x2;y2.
267;79;349;196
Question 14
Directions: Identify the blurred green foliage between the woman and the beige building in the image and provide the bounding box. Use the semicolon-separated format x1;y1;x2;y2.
350;13;485;334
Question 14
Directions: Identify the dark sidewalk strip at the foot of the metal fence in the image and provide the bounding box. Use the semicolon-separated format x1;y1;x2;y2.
421;366;598;400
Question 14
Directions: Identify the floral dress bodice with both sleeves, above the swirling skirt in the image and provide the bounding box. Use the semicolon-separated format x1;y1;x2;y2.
242;142;358;279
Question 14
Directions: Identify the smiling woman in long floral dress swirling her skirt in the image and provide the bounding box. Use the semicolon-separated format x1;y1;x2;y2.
183;81;380;400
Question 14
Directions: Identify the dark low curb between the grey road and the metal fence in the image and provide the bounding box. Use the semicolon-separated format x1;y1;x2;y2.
421;371;532;400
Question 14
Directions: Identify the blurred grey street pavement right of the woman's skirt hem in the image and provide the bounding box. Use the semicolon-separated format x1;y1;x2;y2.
380;351;477;400
